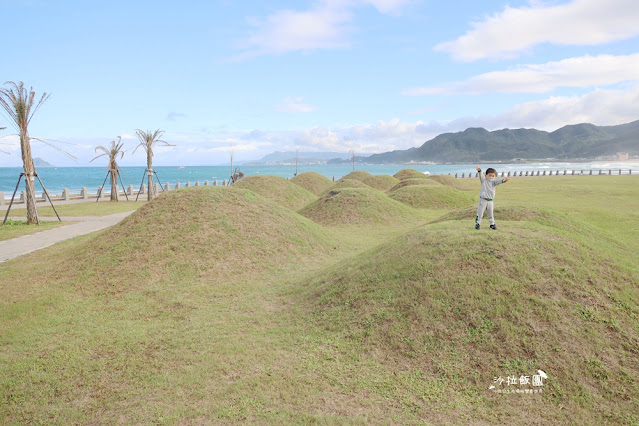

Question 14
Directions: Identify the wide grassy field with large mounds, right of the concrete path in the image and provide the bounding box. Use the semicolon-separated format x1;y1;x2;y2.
0;176;639;424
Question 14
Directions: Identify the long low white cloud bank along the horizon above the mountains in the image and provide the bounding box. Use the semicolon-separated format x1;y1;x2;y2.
0;84;639;166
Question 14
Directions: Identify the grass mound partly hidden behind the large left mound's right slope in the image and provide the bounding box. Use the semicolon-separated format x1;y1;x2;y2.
233;175;317;210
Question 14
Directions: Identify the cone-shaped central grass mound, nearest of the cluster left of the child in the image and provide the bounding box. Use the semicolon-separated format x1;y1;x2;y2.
299;188;420;225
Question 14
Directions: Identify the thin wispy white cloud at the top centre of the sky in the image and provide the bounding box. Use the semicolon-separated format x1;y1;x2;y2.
233;0;410;60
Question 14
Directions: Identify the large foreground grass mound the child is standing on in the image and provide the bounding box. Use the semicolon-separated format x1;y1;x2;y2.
300;216;639;424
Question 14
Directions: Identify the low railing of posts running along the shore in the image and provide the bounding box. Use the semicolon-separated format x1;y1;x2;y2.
0;169;636;206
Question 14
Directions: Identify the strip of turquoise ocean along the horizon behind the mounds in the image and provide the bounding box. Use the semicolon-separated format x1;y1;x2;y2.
0;160;639;198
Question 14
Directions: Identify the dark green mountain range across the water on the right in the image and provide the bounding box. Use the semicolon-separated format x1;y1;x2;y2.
331;120;639;164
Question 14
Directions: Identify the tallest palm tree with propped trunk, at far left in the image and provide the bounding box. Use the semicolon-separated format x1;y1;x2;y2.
0;81;50;224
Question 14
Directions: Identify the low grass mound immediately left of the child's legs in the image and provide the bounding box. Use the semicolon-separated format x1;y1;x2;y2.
389;185;474;209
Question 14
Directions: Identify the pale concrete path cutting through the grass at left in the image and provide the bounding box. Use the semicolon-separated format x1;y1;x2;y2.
0;210;135;263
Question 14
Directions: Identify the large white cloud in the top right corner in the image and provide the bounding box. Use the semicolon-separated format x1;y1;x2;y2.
435;0;639;61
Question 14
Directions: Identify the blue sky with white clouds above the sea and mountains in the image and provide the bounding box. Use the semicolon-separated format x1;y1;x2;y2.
0;0;639;167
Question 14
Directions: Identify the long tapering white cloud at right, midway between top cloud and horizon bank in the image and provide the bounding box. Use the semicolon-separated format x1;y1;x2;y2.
402;53;639;96
